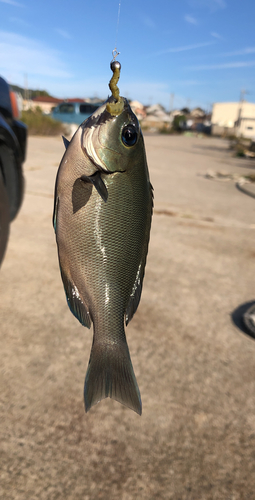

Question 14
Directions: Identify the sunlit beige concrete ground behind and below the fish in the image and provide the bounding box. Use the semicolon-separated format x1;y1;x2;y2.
0;136;255;500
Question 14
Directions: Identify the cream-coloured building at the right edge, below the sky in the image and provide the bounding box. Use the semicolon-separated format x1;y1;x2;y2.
212;101;255;138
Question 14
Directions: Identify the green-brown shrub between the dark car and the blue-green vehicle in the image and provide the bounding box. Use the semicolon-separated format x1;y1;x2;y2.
21;106;65;135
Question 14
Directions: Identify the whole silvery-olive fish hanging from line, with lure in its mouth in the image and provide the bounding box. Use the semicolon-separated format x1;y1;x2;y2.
53;61;153;414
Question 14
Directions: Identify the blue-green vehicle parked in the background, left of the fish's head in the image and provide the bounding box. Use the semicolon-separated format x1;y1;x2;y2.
51;101;102;125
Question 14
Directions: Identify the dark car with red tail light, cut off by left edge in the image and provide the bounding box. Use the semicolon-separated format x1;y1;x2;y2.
0;77;27;265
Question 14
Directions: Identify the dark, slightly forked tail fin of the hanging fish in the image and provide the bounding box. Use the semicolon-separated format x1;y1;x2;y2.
84;342;142;415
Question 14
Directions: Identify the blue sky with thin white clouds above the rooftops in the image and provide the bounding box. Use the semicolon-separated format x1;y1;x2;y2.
0;0;255;109
